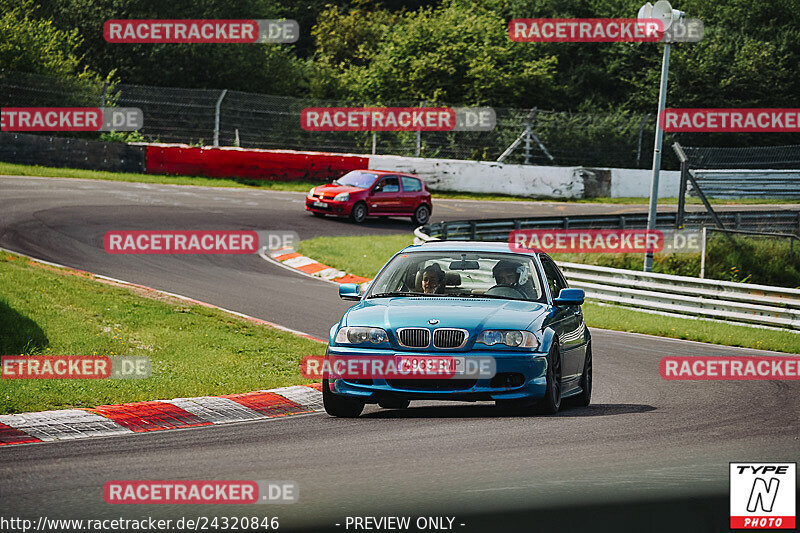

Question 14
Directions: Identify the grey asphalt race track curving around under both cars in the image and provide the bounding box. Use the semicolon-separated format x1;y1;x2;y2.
0;172;800;531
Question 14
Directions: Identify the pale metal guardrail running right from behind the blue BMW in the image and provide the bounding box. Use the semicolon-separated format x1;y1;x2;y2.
414;221;800;331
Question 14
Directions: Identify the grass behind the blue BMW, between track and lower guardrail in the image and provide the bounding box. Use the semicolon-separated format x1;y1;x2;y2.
298;234;800;353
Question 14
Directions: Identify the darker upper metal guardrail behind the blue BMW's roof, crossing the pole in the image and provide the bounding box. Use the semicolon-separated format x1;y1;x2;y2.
422;210;800;241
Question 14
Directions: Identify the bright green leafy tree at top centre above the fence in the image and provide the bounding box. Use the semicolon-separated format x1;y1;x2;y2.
315;1;556;106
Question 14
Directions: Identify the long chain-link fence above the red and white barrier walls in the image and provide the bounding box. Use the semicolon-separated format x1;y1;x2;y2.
0;71;724;168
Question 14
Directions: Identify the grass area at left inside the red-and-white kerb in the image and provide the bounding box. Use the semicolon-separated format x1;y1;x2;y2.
0;252;325;414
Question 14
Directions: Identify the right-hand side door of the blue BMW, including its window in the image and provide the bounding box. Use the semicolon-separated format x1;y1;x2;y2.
540;256;586;382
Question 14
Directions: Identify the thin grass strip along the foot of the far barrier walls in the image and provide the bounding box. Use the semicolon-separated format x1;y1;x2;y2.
0;162;800;205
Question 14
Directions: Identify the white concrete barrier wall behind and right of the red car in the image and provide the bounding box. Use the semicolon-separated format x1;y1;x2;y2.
369;155;680;198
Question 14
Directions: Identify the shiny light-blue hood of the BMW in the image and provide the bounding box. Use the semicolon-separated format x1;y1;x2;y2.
342;296;548;331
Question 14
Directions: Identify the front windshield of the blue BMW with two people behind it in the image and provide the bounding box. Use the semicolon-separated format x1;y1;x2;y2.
366;251;545;302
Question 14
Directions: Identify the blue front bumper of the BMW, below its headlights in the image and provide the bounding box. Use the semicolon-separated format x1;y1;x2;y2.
329;347;547;403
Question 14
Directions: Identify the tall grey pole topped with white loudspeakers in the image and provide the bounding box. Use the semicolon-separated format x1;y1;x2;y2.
638;0;686;272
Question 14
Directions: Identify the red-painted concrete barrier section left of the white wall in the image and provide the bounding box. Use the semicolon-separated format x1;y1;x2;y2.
146;144;369;181
